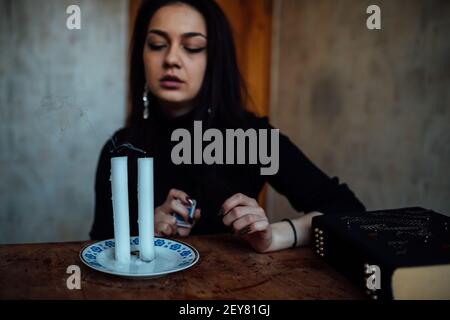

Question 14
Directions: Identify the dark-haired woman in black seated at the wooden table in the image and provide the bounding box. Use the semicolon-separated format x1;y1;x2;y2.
90;0;365;252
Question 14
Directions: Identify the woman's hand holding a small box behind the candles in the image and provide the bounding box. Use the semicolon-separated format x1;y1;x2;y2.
155;189;200;237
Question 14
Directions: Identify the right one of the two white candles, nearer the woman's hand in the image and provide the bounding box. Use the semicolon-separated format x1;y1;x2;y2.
138;158;155;262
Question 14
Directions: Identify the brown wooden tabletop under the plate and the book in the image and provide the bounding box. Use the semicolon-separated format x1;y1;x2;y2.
0;235;365;300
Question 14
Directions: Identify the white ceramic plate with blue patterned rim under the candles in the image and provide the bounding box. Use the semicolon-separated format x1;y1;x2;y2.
80;237;200;278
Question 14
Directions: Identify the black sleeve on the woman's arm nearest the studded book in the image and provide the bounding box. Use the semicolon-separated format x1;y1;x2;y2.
259;118;366;214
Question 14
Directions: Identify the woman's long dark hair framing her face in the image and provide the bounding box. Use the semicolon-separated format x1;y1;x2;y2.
127;0;248;128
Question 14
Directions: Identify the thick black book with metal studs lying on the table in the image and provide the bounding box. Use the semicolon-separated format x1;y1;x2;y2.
312;207;450;300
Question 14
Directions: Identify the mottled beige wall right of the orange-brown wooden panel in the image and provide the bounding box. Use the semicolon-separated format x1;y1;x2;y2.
268;0;450;220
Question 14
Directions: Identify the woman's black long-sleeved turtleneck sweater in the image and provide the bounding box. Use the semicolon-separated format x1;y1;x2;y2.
90;107;365;240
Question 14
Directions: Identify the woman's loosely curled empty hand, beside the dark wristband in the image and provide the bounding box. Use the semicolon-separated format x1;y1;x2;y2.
220;193;272;252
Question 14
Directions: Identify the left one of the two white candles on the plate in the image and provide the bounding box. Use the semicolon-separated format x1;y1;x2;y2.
111;157;130;263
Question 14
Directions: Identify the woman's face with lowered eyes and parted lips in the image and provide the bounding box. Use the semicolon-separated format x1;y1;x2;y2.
143;4;207;115
